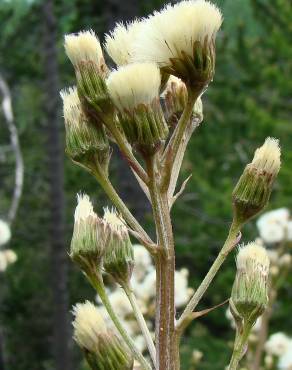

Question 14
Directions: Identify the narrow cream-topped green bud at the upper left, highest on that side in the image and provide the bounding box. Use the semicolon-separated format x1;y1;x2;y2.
65;30;110;115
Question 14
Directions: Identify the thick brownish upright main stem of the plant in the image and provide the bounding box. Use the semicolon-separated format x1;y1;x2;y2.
146;158;175;370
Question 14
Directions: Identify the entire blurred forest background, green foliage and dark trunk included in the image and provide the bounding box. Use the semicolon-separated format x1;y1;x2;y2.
0;0;292;370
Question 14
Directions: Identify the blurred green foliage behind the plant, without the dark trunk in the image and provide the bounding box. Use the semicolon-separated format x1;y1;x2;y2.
0;0;292;370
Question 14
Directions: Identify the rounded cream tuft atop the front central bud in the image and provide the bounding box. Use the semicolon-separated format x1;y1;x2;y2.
107;63;161;111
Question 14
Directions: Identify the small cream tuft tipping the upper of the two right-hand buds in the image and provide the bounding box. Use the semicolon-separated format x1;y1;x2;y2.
252;137;281;176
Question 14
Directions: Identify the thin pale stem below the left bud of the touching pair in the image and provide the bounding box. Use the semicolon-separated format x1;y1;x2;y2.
88;273;152;370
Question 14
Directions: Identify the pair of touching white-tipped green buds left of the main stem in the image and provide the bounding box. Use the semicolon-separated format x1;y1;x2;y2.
70;195;134;284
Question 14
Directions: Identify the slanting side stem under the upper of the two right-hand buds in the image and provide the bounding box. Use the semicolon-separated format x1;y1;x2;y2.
176;221;241;332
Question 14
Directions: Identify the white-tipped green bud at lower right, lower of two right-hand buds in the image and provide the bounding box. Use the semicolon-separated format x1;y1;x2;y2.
231;243;270;324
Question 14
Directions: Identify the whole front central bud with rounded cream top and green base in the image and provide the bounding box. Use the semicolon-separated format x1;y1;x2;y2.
107;63;168;154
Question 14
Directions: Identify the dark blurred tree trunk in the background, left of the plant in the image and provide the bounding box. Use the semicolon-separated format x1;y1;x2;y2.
42;0;72;370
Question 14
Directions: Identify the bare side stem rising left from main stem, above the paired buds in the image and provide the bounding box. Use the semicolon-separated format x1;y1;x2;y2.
94;164;156;255
